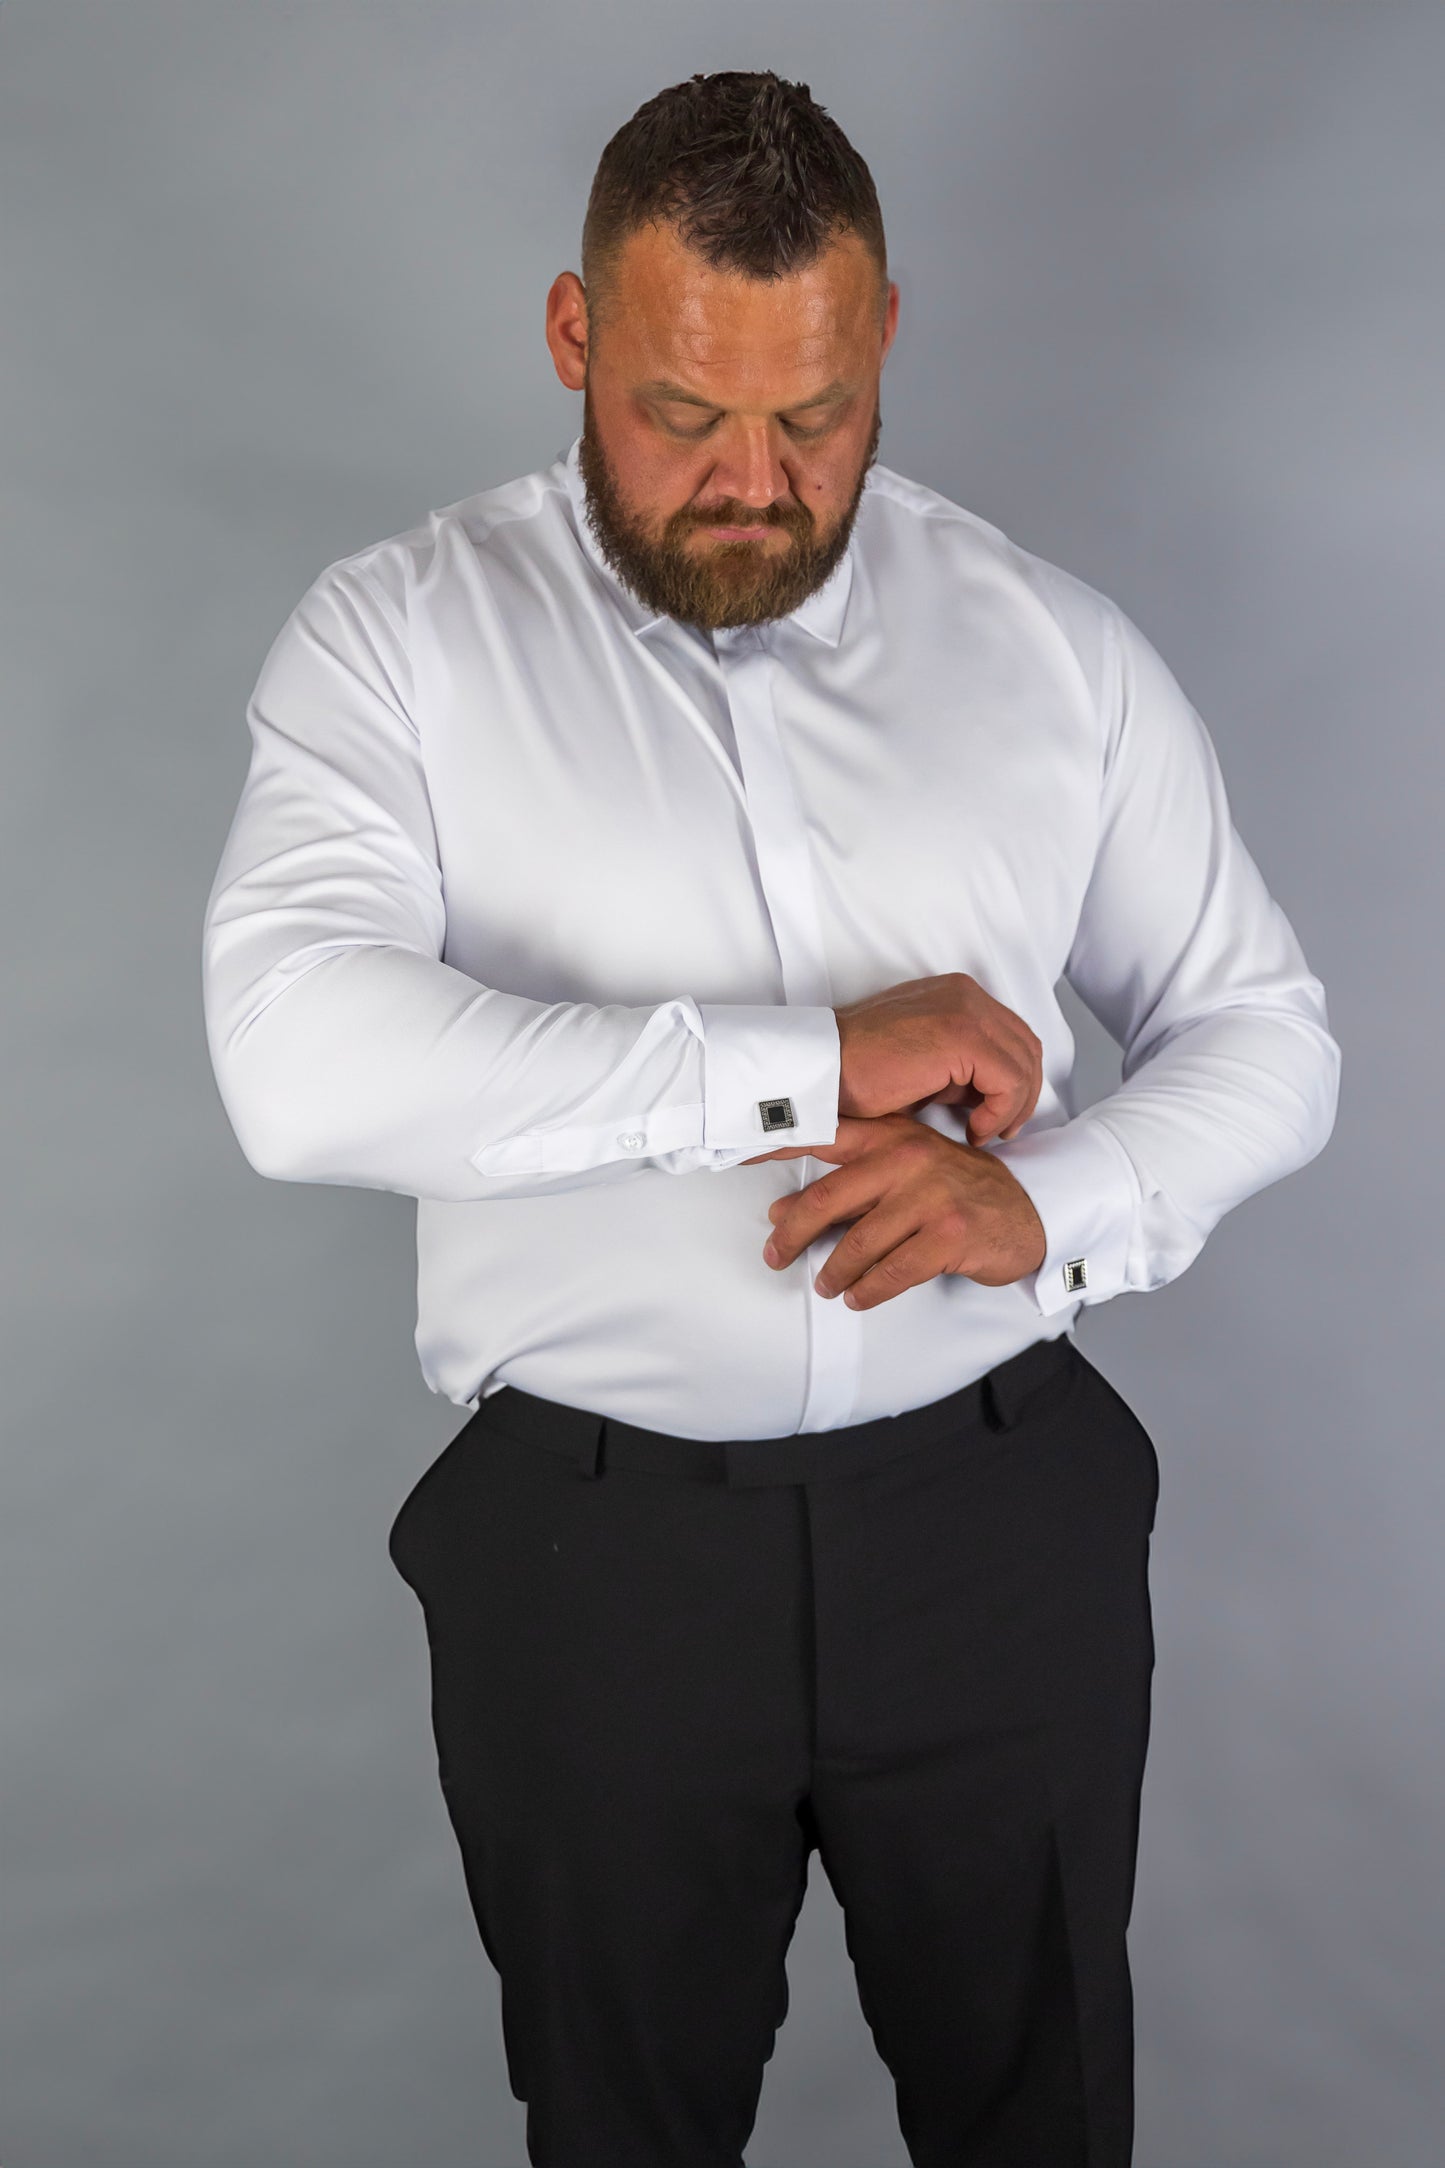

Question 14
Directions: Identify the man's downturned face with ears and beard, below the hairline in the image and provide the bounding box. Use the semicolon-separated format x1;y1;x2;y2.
548;225;897;631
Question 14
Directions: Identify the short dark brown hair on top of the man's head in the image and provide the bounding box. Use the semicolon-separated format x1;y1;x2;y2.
583;69;888;327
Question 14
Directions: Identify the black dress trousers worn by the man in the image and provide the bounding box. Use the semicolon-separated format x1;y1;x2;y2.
388;1335;1159;2168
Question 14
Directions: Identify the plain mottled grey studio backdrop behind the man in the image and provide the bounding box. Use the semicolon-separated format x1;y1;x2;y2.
0;0;1445;2168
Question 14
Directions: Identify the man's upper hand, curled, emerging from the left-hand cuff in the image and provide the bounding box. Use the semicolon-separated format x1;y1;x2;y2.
823;971;1044;1164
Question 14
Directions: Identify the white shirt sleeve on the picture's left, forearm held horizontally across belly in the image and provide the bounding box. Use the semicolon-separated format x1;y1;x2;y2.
201;562;838;1203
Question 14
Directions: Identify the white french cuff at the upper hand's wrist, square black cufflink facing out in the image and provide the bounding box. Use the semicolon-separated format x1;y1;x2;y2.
698;1002;843;1169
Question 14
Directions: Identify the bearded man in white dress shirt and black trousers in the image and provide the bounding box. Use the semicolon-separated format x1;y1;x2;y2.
206;72;1339;2168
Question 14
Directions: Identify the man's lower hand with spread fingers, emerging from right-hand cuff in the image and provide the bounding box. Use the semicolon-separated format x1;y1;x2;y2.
741;1114;1049;1309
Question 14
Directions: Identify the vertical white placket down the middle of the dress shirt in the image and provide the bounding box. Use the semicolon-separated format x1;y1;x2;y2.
715;627;862;1431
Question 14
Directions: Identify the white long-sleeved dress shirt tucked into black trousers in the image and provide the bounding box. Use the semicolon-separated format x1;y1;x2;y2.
204;427;1339;1437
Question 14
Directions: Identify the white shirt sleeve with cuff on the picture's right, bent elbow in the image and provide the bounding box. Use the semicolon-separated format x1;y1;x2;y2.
984;598;1341;1318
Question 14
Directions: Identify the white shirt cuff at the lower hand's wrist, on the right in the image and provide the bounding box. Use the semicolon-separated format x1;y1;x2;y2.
984;1112;1140;1318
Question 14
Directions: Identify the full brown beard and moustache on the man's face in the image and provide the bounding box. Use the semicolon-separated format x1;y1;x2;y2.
578;384;884;633
